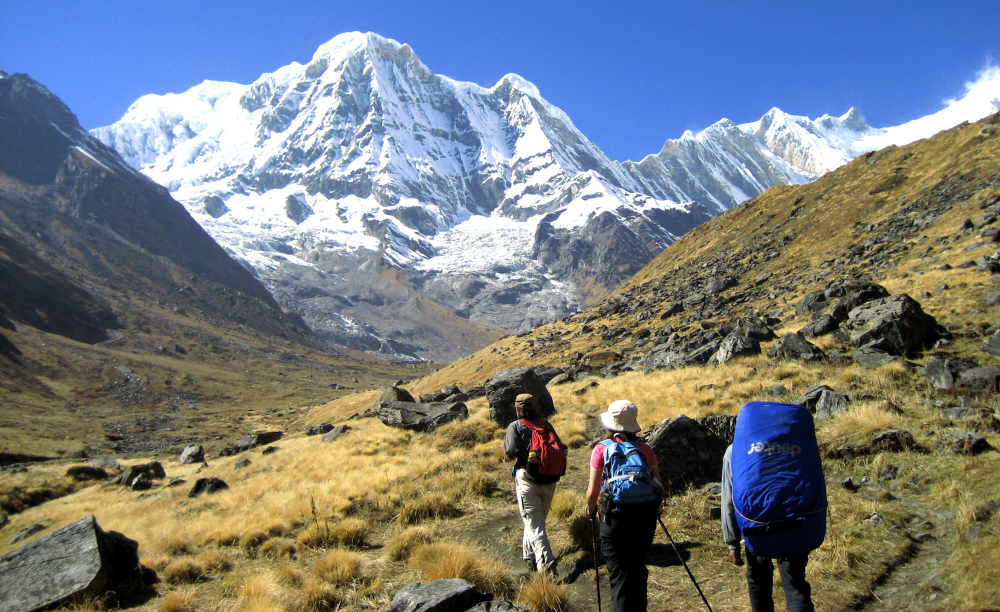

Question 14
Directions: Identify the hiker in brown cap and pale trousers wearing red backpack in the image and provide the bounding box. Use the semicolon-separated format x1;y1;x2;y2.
503;393;566;576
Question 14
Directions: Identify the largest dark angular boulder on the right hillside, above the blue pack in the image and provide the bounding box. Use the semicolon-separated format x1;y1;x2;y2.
841;293;940;357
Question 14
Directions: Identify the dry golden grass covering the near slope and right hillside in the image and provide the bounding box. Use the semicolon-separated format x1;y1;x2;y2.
0;112;1000;610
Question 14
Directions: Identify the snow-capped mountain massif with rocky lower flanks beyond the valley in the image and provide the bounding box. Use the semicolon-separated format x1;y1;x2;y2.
93;33;1000;359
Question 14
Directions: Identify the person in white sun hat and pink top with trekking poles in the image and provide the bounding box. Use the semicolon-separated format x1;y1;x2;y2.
586;400;663;612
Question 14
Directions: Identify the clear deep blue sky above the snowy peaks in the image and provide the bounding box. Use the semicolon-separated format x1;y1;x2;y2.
0;0;1000;160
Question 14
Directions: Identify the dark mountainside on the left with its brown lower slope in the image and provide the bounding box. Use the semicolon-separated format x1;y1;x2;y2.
0;75;426;454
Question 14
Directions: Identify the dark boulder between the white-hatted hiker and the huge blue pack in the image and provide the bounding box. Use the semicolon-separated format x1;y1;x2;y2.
646;415;729;495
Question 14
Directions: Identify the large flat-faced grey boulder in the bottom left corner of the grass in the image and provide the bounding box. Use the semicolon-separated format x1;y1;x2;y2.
0;515;153;612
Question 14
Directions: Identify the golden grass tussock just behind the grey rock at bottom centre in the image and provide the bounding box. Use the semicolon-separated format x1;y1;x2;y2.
409;542;513;599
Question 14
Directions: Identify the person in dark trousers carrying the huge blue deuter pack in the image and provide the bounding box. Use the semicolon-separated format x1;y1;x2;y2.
722;402;827;612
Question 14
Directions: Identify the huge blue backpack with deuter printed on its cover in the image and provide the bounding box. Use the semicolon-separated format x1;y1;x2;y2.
732;402;826;558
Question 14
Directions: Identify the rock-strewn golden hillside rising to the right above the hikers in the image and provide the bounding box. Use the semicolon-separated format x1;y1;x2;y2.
416;115;1000;392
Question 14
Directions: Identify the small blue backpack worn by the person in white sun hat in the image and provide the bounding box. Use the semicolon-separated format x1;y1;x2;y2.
600;440;663;514
